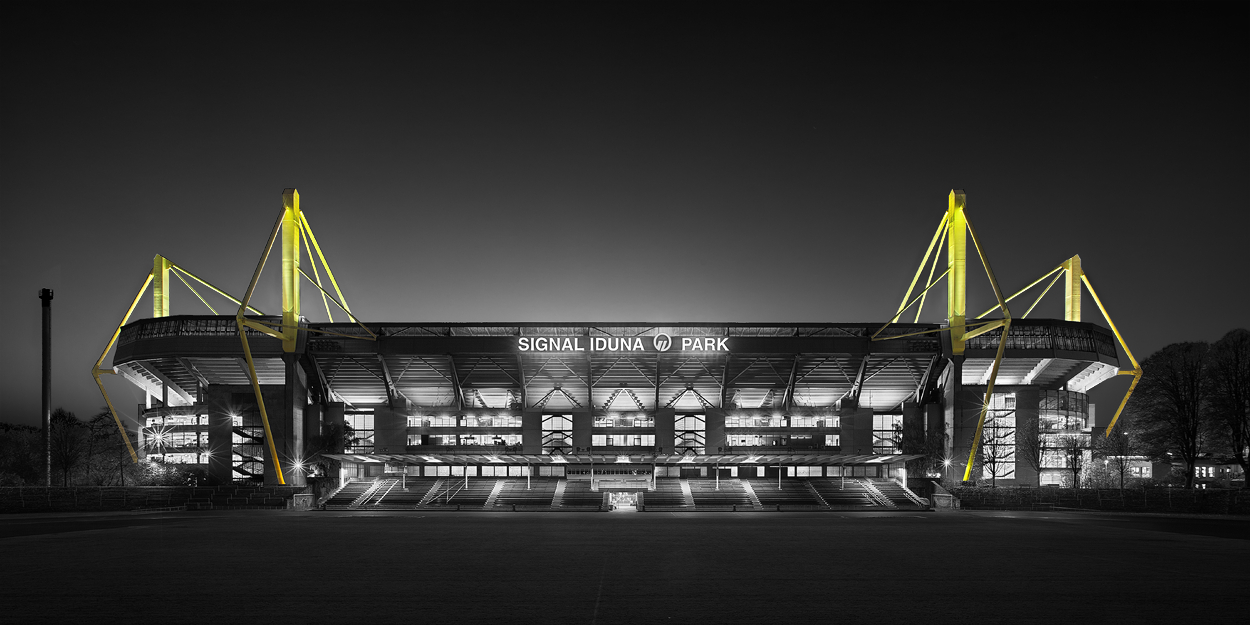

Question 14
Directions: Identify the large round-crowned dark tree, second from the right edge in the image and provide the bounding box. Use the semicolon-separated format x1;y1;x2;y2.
1128;343;1213;488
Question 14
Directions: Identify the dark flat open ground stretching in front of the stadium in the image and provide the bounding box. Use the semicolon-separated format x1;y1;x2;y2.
0;511;1250;625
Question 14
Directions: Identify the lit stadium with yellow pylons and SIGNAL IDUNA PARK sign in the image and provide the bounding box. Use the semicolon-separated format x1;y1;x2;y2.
93;189;1140;510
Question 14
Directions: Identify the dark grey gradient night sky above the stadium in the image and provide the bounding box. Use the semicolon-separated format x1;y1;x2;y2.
0;3;1250;424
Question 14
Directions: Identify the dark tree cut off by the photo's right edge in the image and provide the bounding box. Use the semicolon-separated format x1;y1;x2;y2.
1209;329;1250;484
